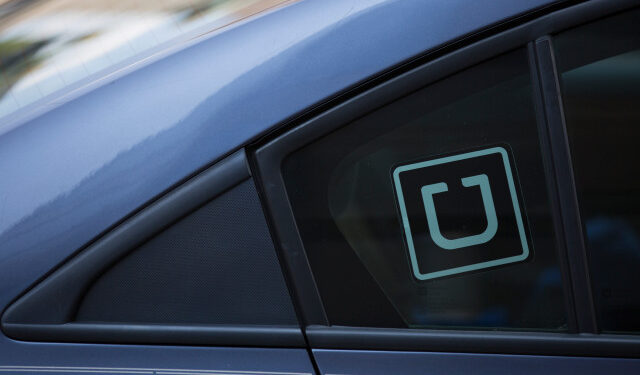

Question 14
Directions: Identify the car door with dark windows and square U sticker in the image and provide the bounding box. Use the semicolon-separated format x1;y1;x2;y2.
252;1;640;374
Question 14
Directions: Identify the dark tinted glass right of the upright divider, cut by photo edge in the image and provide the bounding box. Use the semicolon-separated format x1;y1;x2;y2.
554;10;640;332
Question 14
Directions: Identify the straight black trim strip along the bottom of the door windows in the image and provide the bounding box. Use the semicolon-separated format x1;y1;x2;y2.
305;326;640;358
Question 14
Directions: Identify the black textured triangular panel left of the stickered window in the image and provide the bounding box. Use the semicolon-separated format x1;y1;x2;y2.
75;180;297;325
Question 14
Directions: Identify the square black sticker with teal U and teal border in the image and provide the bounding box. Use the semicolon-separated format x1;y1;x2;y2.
393;147;529;280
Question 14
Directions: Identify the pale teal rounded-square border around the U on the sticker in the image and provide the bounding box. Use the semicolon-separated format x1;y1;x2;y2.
392;147;529;281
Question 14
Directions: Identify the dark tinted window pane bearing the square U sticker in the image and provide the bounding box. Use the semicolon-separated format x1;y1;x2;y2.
283;50;566;330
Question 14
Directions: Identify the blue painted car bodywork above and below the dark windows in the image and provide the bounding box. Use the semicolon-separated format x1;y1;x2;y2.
0;0;640;374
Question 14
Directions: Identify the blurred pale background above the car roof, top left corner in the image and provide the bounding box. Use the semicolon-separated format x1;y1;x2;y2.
0;0;288;118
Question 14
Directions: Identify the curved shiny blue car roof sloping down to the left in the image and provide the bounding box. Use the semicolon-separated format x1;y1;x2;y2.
0;0;553;298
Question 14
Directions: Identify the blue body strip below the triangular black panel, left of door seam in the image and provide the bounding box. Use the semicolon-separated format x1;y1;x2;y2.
0;346;313;375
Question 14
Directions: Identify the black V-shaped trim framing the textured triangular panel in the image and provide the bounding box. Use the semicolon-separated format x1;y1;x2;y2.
1;149;306;347
